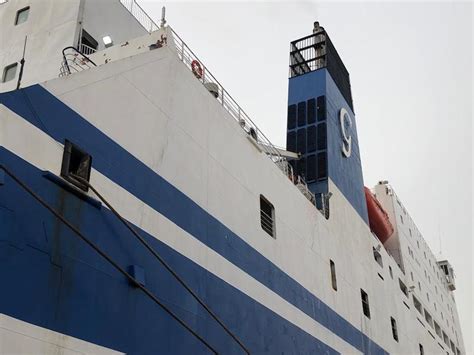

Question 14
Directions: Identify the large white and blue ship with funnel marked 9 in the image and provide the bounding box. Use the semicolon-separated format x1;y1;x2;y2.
0;0;465;355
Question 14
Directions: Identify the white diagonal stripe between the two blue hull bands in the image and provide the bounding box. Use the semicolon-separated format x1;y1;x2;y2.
0;105;360;354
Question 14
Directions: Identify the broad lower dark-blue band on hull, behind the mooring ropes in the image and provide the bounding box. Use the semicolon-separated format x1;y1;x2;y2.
0;148;338;354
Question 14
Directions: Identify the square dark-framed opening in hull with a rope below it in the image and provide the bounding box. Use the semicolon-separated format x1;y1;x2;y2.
61;140;92;191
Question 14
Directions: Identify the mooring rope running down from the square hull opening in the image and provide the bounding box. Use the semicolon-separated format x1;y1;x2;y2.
70;174;250;355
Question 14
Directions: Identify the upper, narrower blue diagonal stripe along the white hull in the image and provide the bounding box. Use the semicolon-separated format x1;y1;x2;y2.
0;85;385;353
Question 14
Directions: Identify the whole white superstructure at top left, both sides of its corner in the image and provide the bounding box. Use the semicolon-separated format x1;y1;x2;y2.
0;0;147;92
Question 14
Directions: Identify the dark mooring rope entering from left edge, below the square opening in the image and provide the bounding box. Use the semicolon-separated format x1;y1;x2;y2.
0;164;218;355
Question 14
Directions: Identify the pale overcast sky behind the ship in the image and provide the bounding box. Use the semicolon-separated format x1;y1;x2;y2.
140;0;474;354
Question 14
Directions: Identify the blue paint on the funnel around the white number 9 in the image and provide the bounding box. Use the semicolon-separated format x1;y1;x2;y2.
288;68;368;223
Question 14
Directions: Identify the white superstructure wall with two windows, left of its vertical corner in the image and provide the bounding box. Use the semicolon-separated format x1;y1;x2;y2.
0;0;81;92
